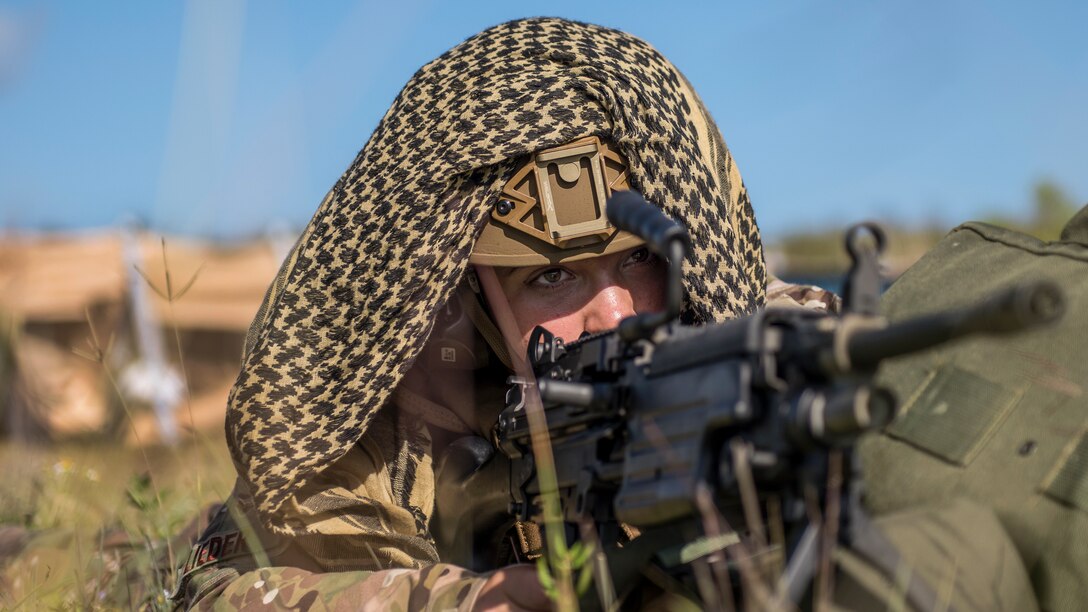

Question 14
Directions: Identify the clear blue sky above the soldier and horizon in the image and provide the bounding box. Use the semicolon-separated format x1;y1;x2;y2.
0;0;1088;238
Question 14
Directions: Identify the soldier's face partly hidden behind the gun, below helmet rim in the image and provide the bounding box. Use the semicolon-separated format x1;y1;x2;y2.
487;247;667;355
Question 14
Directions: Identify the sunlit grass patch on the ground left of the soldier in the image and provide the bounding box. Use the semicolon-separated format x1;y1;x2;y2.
0;438;234;610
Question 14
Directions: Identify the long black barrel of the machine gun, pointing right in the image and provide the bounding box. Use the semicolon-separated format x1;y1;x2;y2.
846;281;1064;368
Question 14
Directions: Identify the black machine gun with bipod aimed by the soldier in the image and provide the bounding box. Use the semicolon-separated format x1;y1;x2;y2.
433;192;1062;602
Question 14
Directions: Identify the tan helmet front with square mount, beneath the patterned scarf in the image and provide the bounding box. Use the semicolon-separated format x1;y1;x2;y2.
470;136;642;267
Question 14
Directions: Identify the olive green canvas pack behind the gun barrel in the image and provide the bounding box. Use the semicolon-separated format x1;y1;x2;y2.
861;207;1088;610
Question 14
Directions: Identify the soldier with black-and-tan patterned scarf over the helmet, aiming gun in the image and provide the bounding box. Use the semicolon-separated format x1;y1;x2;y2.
176;19;792;609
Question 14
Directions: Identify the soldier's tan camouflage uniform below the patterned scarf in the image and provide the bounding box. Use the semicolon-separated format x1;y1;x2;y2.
176;406;498;610
